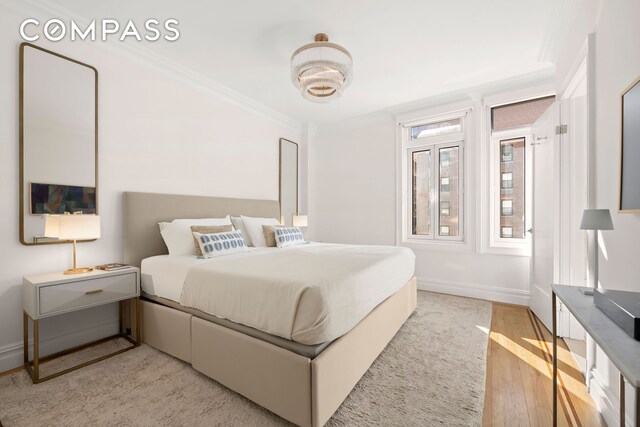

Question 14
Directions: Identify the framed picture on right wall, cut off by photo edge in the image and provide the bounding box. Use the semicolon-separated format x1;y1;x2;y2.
618;77;640;214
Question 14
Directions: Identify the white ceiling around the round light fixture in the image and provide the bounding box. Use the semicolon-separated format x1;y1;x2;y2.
51;0;566;123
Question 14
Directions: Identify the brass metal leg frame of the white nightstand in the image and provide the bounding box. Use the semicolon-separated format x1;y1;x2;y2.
23;297;141;384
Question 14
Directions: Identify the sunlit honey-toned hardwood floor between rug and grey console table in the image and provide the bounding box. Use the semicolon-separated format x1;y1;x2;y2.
483;303;606;427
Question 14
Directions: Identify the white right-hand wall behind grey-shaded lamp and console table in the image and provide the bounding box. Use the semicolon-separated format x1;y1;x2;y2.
557;0;640;425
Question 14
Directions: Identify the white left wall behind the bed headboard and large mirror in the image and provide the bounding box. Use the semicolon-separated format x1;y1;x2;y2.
0;6;306;372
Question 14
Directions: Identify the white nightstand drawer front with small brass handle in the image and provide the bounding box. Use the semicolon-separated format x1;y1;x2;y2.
39;273;138;316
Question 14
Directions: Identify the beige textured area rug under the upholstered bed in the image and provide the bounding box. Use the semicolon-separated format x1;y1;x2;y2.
0;292;491;427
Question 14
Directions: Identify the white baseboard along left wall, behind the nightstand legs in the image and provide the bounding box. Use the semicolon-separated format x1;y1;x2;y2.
0;320;118;373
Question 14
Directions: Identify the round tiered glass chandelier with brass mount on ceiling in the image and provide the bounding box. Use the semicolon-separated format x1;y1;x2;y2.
291;33;353;102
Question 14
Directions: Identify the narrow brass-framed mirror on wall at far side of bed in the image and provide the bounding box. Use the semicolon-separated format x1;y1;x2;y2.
280;138;298;225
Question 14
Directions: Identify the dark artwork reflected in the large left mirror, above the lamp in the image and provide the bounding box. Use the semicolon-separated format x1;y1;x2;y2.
31;183;96;215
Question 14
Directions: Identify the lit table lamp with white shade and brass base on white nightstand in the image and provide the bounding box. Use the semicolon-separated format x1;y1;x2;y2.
44;213;100;274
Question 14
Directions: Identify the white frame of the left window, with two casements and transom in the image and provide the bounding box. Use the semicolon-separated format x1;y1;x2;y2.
401;115;467;244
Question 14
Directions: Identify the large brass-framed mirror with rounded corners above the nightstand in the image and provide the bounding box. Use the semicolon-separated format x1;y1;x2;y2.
19;43;98;245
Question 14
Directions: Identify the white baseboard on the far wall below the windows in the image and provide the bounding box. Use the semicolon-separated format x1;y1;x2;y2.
418;277;529;306
